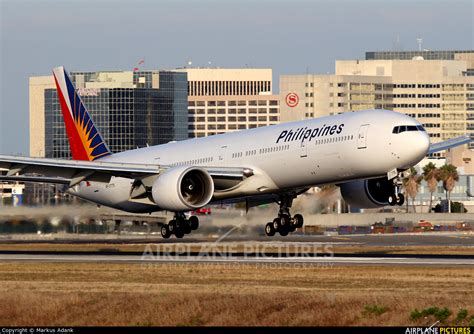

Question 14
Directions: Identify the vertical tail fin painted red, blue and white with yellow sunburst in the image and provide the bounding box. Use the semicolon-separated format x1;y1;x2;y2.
53;66;112;161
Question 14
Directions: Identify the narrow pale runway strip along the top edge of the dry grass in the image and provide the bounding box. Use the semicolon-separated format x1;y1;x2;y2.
0;253;474;266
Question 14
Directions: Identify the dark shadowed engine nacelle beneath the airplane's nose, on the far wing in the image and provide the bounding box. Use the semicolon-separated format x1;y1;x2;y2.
339;177;394;209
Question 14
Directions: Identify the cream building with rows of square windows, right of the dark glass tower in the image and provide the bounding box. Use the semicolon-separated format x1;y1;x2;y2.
176;68;280;138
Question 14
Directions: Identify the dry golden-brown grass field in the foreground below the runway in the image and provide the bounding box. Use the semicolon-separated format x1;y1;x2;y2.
0;262;474;326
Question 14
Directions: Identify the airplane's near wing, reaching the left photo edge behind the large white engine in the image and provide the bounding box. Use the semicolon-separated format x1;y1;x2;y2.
0;155;252;187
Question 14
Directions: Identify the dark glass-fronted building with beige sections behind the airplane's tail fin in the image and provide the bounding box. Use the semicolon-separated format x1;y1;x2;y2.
30;71;188;158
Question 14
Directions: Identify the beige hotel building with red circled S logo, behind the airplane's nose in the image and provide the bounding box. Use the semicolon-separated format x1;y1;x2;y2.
280;55;474;157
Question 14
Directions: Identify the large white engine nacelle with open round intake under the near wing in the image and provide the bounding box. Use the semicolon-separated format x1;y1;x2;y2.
151;166;214;211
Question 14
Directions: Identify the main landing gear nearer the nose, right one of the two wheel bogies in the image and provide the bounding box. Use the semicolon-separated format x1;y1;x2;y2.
265;196;303;237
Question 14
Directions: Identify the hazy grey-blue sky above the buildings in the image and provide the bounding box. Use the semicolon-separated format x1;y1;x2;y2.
0;0;474;155
